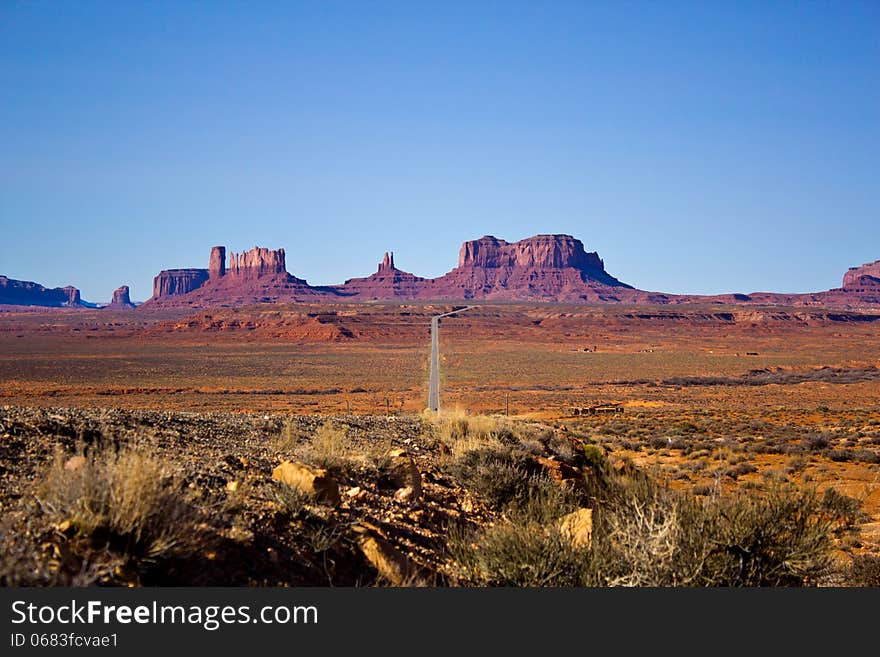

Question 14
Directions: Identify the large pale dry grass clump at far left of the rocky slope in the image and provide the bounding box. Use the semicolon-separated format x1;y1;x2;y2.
39;446;196;560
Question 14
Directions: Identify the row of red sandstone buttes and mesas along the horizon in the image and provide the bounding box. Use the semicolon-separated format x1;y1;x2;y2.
0;235;880;310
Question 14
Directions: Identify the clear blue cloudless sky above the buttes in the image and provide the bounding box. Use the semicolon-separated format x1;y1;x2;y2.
0;0;880;301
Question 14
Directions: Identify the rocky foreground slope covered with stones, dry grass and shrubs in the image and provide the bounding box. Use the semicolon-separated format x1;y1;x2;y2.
0;406;877;586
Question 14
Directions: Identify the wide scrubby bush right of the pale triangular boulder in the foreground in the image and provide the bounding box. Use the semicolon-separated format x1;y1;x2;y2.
593;479;832;586
